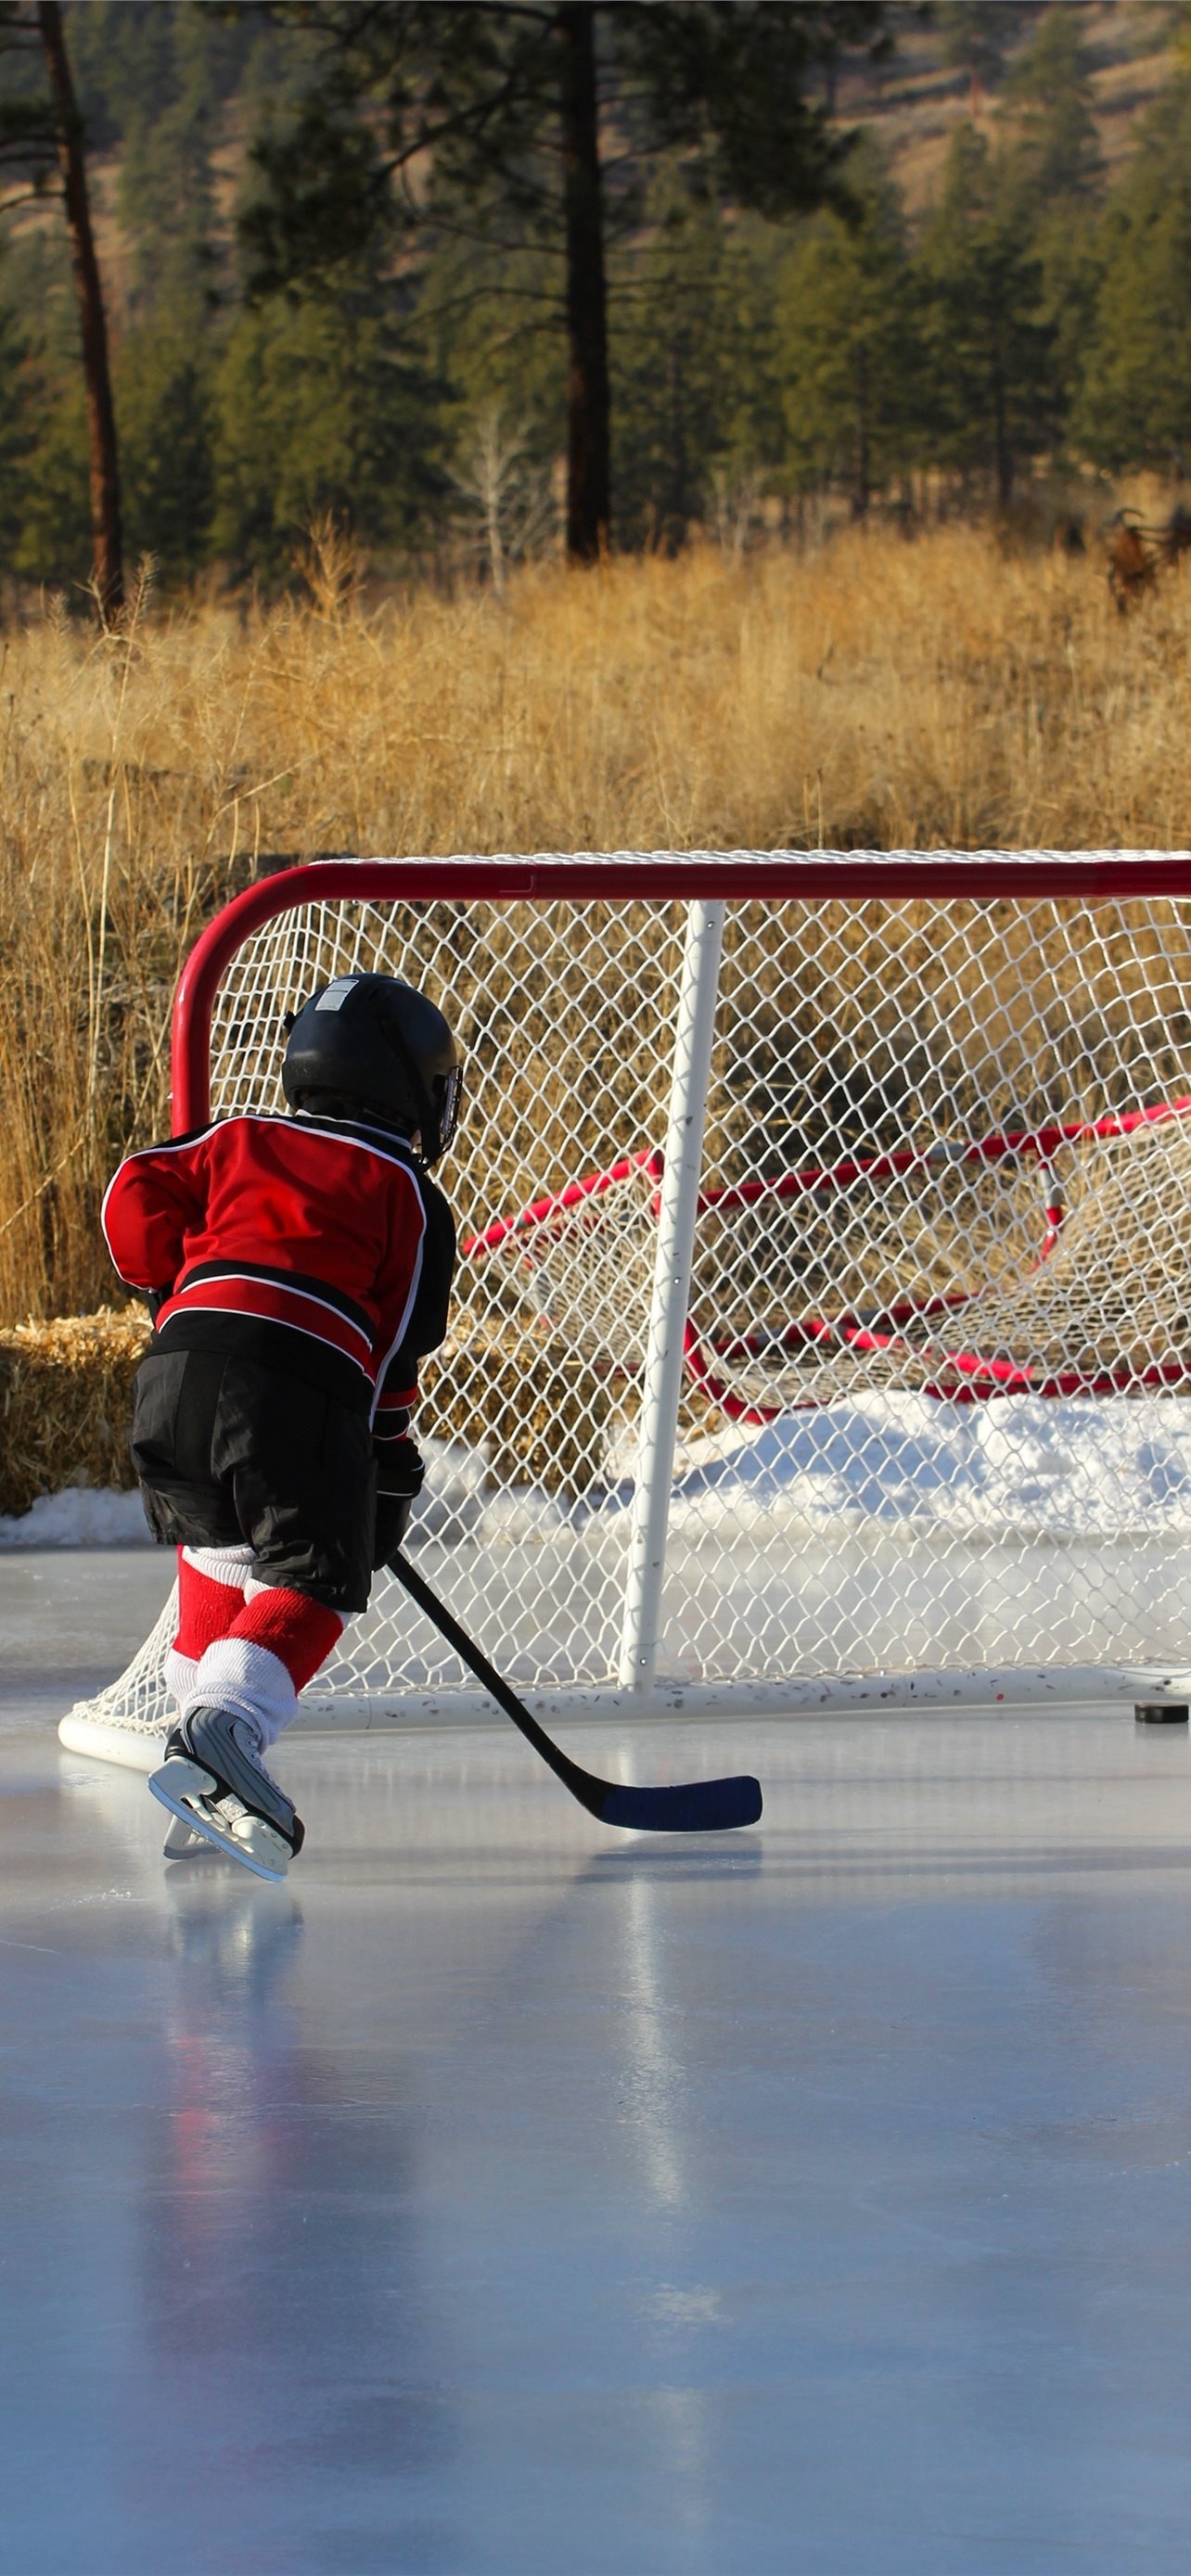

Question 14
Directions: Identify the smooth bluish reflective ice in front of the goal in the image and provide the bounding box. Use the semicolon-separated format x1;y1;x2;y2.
0;1550;1191;2576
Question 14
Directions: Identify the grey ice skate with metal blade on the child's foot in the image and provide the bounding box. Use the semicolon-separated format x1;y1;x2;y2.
149;1708;304;1878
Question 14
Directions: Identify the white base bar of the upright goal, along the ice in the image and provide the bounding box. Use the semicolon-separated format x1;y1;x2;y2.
57;1664;1188;1772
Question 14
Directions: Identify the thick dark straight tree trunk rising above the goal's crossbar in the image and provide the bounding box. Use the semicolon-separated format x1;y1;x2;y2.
559;0;611;564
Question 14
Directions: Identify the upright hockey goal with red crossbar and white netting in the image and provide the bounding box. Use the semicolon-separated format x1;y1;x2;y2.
59;850;1191;1765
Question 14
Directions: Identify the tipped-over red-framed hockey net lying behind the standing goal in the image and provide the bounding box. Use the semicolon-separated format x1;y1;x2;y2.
477;1097;1191;1422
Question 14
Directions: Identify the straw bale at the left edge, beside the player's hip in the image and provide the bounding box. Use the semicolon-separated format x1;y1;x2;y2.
0;1306;149;1514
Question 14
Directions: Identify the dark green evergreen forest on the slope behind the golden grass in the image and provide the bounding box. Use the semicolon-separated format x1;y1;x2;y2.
0;0;1191;595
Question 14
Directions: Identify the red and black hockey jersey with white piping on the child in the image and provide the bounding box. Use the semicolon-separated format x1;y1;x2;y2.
103;1110;454;1430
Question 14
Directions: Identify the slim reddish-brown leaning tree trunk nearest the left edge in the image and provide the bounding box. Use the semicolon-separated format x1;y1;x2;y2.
36;0;123;618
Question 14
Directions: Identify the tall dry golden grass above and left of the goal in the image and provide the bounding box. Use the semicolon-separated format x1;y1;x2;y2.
0;528;1191;1317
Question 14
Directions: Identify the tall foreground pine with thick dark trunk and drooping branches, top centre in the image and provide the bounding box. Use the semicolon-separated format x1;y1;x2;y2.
248;0;881;562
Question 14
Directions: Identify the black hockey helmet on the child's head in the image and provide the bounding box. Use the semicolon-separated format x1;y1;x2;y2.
281;974;464;1162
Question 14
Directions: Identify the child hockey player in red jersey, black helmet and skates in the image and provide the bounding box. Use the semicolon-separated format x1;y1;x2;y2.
103;974;461;1878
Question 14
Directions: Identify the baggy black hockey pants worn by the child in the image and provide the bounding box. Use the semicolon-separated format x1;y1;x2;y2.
132;1350;377;1613
